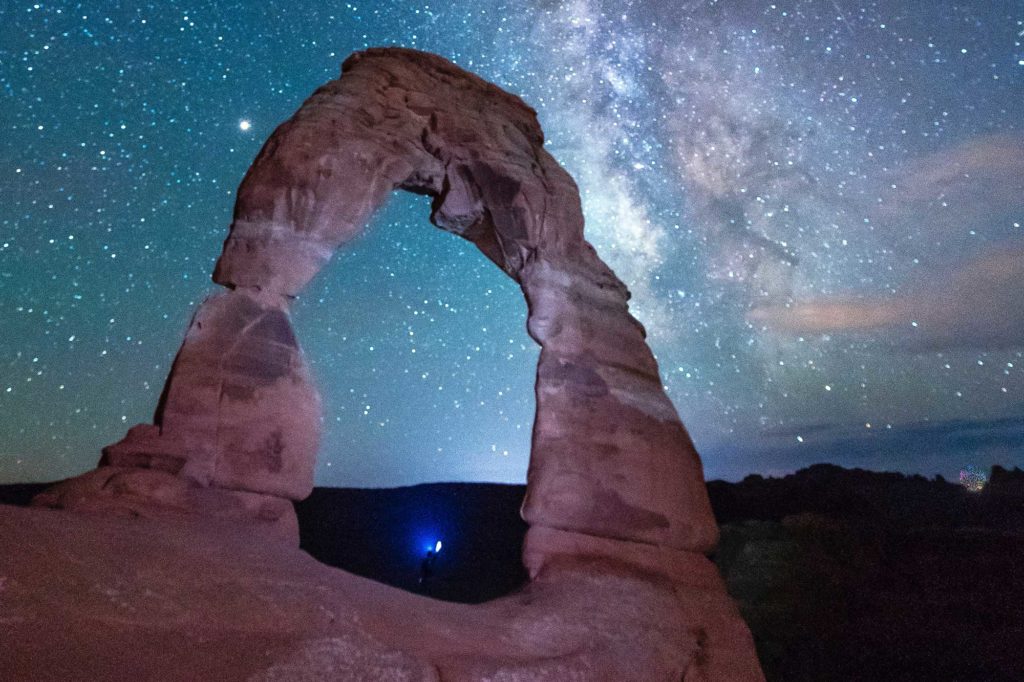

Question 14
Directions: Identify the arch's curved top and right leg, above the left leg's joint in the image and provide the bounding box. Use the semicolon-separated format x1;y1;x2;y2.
214;49;716;551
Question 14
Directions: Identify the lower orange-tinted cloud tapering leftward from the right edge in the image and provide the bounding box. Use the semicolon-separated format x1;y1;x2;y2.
748;242;1024;351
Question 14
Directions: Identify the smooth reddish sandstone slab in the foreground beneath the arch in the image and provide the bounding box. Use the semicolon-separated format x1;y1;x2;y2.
0;506;760;682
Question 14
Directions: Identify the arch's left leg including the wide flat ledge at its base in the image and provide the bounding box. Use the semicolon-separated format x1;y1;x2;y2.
35;289;321;544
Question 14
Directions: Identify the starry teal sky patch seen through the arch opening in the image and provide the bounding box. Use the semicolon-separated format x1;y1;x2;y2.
292;191;539;487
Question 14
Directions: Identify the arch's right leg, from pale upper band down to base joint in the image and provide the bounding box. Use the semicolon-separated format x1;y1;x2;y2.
522;249;718;552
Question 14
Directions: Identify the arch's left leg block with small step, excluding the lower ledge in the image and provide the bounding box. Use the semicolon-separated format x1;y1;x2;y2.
102;291;321;500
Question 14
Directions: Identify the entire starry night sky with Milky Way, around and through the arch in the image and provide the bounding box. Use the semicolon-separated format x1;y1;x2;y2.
0;0;1024;486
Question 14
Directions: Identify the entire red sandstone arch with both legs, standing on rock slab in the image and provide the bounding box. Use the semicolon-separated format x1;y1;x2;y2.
32;48;757;679
